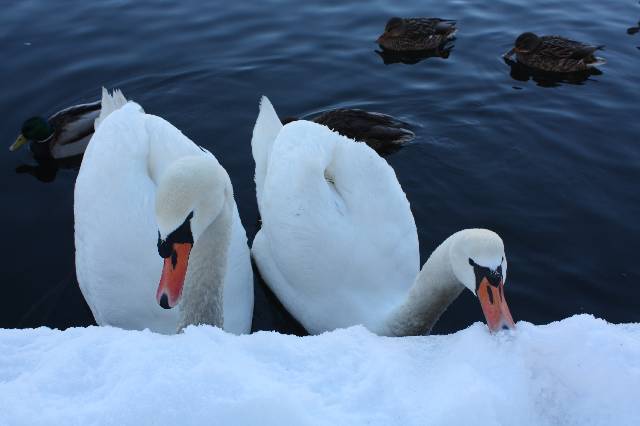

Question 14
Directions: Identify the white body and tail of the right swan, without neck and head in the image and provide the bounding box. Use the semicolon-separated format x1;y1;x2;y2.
252;98;419;333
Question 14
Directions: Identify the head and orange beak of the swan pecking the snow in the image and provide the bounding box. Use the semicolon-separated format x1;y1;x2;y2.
450;229;515;332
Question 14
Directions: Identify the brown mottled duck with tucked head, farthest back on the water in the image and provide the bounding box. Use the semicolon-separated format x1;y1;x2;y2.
376;17;456;51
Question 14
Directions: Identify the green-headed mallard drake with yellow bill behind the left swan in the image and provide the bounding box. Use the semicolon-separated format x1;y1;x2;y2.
9;101;100;160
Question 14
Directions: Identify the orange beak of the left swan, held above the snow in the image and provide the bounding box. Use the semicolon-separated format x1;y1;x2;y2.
156;243;193;309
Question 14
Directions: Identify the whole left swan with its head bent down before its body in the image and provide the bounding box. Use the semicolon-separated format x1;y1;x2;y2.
74;89;253;333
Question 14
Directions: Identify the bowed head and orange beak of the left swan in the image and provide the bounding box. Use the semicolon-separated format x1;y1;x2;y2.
156;155;233;309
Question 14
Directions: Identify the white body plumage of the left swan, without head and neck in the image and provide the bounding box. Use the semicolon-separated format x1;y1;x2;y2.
74;94;253;333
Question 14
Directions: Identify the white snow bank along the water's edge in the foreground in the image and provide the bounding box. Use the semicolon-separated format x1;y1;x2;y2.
0;315;640;426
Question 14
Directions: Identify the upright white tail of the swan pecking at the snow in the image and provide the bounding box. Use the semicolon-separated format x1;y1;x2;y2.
251;96;282;207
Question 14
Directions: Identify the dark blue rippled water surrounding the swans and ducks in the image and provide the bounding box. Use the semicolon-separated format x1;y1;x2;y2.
0;0;640;332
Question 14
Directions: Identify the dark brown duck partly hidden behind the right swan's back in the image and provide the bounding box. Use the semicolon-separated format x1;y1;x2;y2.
282;108;415;154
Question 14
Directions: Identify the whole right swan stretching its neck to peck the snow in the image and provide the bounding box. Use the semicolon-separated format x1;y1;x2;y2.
252;98;514;336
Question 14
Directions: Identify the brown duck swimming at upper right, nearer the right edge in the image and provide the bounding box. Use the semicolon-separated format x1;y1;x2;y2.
505;32;605;73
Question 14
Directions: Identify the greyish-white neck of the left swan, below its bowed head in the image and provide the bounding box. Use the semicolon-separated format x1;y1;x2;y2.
178;191;234;331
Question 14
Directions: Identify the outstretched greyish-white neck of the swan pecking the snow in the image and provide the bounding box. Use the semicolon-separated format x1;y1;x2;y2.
379;234;465;336
